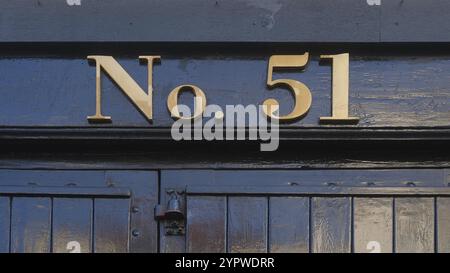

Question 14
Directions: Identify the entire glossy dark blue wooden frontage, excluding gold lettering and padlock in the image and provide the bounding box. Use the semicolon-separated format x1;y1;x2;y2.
0;0;450;255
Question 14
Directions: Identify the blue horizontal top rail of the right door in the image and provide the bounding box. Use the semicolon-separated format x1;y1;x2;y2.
161;169;450;189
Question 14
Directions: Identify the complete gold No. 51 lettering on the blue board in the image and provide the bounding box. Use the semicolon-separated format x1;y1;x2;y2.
87;52;359;124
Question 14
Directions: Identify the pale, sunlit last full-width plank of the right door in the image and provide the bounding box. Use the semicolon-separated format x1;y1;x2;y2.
395;197;434;252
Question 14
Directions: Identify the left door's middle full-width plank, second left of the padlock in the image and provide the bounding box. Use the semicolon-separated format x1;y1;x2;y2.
52;198;93;253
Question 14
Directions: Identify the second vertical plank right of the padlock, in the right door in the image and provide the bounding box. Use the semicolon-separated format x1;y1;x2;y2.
228;196;268;253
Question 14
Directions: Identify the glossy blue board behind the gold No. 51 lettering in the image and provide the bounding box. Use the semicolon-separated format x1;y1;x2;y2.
0;52;450;128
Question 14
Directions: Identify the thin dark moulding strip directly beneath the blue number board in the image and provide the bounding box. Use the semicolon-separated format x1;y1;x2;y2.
0;127;450;142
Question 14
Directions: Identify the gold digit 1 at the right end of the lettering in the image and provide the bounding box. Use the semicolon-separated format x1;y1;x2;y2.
320;53;359;124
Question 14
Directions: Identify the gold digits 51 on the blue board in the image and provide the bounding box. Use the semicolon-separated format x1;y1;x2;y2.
263;52;359;124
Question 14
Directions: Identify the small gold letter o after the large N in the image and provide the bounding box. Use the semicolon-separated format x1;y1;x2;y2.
167;84;206;119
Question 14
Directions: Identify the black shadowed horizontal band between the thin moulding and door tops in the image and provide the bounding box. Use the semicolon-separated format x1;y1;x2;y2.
0;140;450;169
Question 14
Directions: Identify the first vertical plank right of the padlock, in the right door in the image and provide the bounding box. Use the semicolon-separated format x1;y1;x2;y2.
186;196;227;253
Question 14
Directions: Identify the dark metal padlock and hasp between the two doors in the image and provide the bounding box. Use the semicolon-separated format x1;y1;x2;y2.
155;189;185;236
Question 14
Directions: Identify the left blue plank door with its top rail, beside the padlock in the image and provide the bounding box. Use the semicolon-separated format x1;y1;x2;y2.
0;170;158;253
